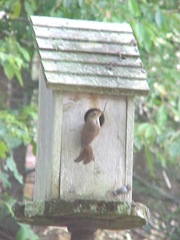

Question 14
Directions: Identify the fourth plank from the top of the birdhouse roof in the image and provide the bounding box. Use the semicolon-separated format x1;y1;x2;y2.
40;50;142;68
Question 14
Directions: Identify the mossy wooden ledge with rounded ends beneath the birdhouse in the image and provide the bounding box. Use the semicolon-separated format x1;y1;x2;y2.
13;200;150;230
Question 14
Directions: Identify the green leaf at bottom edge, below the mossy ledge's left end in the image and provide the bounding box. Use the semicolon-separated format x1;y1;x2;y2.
16;223;39;240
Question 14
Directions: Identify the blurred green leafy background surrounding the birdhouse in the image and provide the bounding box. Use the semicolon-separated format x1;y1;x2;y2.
0;0;180;240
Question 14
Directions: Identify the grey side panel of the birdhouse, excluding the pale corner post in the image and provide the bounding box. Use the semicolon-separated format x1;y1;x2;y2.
34;70;53;200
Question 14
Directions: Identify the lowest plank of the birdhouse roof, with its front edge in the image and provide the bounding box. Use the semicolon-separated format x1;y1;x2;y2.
45;72;149;95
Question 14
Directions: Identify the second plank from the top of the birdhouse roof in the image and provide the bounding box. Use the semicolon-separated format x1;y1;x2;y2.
34;26;136;45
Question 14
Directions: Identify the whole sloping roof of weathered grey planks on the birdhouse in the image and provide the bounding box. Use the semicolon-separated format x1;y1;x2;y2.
31;16;149;95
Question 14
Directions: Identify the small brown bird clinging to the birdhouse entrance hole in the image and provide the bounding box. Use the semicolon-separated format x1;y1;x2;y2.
74;108;104;164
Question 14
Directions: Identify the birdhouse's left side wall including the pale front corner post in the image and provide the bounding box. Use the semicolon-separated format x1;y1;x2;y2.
34;74;62;200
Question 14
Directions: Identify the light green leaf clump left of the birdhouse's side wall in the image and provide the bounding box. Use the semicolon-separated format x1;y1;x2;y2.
0;106;37;185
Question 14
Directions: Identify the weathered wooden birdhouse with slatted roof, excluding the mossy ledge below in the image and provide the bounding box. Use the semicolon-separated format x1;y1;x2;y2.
31;16;149;202
